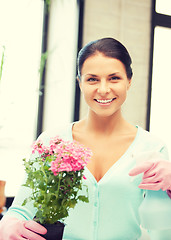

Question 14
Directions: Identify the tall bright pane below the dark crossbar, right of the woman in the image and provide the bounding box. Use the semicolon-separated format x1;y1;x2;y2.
150;27;171;156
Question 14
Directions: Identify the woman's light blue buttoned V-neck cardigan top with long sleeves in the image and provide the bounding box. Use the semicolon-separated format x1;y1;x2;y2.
4;124;171;240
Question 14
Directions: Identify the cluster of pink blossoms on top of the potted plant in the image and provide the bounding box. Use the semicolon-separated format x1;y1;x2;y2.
32;136;92;175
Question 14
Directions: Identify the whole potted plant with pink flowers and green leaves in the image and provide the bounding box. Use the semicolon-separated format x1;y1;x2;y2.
23;136;92;240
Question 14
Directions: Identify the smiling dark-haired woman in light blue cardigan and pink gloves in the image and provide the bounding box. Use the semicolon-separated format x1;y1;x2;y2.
0;38;171;240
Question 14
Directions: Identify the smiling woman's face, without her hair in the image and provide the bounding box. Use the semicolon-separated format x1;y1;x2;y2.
80;53;131;117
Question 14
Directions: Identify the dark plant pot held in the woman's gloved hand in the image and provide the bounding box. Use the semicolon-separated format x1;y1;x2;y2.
40;222;65;240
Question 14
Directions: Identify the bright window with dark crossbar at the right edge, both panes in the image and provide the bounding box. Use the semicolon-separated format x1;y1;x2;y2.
149;0;171;156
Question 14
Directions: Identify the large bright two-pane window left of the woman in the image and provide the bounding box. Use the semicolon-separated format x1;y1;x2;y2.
0;0;80;196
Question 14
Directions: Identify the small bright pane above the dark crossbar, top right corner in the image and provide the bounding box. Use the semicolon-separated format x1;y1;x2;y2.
156;0;171;15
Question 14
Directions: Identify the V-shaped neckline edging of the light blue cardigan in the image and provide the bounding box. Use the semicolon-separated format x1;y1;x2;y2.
70;122;140;185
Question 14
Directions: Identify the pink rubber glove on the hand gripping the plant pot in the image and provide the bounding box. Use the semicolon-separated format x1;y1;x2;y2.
0;216;47;240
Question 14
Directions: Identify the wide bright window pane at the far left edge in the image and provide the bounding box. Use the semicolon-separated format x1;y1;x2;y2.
0;0;43;196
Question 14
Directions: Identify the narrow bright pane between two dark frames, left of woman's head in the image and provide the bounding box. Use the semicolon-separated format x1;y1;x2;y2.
43;0;79;130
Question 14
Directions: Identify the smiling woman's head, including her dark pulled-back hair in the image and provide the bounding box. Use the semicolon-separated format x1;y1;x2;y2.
77;38;132;121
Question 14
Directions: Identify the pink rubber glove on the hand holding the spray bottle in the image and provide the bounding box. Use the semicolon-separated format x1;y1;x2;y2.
129;160;171;192
